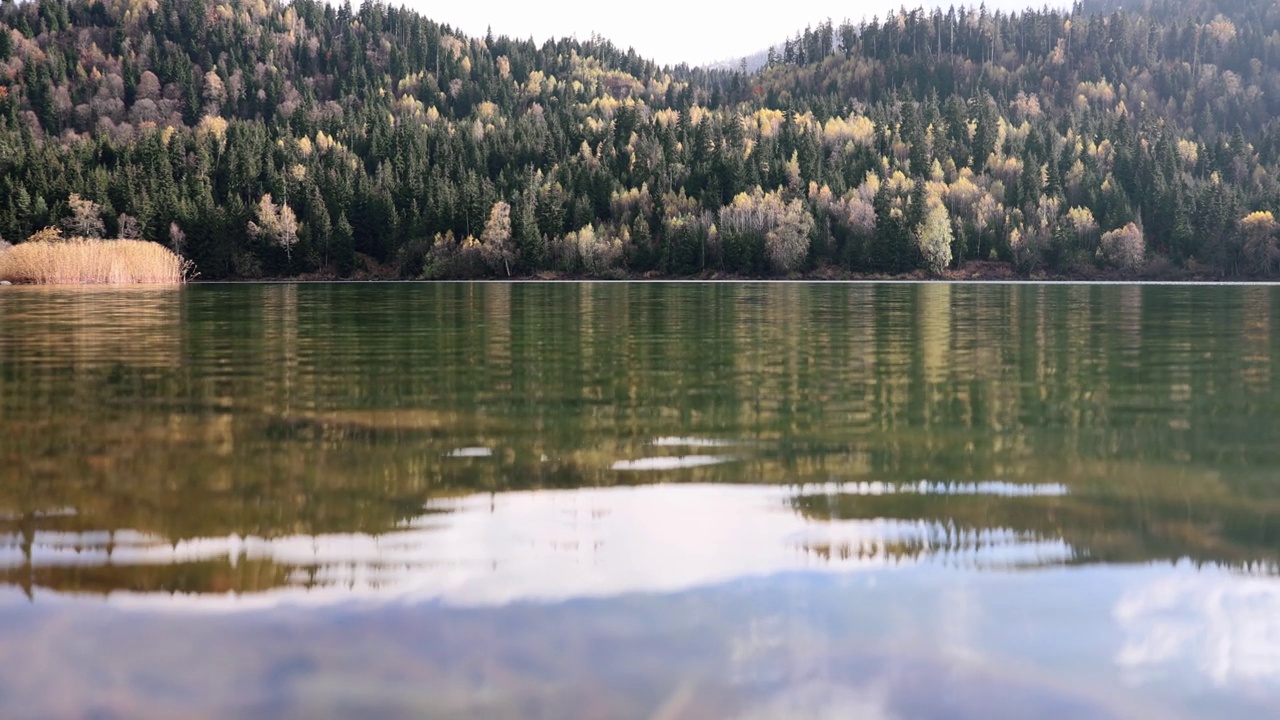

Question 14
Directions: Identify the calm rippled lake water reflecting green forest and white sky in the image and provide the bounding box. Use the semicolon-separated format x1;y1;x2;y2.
0;283;1280;720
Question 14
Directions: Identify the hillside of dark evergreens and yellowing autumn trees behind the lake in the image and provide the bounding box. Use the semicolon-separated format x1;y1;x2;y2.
0;0;1280;278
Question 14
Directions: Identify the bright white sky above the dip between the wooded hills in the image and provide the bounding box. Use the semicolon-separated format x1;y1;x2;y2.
406;0;1066;65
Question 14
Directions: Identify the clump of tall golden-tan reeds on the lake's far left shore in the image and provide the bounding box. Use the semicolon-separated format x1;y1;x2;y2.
0;238;191;284
